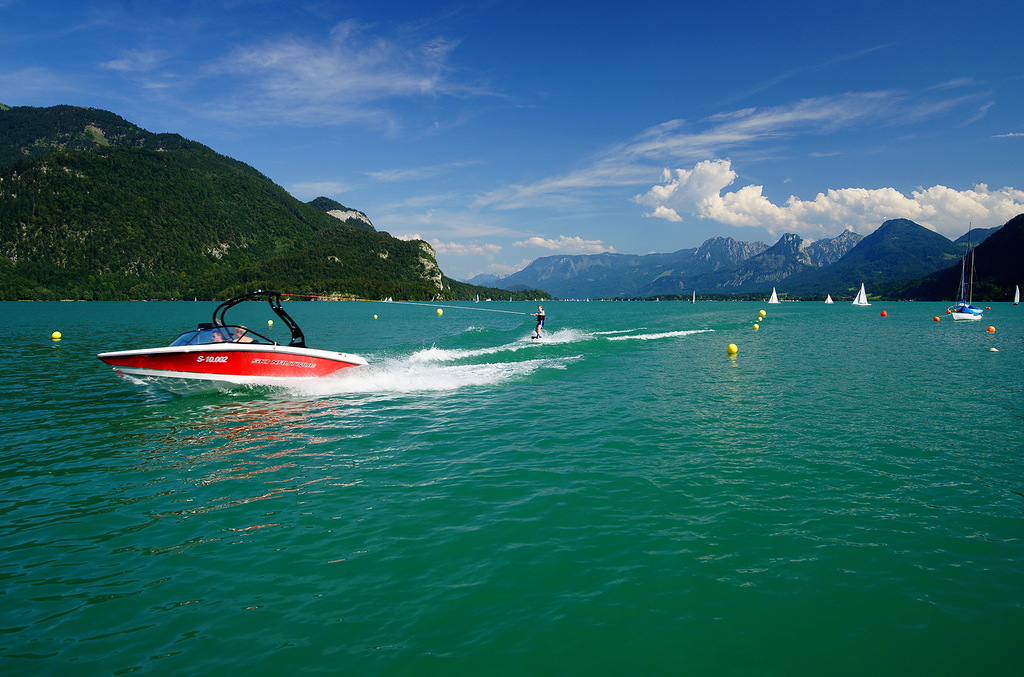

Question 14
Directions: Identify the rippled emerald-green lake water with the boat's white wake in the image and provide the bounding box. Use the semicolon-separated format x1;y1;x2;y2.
0;302;1024;676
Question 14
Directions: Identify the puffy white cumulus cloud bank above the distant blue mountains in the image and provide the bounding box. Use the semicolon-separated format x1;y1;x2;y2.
634;159;1024;238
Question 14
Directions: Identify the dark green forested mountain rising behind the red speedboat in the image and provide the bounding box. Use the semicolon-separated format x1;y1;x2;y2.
0;105;540;300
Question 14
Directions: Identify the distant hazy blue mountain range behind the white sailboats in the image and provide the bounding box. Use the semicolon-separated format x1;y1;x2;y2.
471;217;1024;299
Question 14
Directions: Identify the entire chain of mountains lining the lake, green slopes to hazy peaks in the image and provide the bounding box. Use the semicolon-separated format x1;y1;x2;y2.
0;104;1024;300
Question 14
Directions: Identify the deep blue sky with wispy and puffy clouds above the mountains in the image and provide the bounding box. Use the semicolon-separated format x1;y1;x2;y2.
0;0;1024;279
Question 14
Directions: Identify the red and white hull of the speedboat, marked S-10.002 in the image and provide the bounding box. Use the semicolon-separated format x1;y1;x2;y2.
96;343;367;385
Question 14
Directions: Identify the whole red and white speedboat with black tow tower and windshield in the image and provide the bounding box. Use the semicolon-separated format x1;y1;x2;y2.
96;291;367;389
